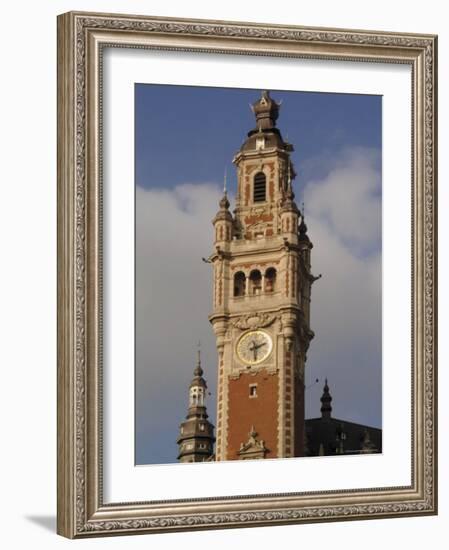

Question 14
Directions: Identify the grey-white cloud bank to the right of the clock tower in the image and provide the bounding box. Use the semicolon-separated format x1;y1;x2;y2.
304;148;382;424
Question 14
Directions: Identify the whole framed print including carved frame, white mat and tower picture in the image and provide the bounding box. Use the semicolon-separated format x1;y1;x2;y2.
58;12;437;538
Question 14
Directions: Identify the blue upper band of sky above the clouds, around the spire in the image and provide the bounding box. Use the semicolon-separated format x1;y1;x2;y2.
135;84;382;196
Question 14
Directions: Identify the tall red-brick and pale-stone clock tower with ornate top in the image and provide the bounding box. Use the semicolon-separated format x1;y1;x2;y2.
209;91;316;460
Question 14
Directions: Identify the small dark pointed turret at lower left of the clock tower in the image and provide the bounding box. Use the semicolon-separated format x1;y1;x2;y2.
177;350;215;462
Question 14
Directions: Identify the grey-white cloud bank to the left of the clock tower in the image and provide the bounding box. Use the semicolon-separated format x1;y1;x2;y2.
136;184;220;462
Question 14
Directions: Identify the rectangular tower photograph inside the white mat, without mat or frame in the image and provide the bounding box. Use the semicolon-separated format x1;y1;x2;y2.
134;83;382;465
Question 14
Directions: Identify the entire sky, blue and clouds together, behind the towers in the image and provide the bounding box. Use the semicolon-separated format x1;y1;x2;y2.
135;84;382;464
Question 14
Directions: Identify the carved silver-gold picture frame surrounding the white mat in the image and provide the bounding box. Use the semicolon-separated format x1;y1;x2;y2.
57;12;437;538
